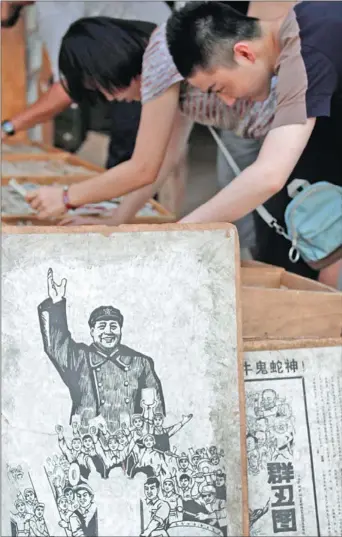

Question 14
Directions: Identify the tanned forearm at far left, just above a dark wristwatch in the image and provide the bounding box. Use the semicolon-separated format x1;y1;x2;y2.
2;82;72;137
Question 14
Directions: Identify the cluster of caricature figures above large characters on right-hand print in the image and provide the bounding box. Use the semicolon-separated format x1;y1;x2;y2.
246;388;295;476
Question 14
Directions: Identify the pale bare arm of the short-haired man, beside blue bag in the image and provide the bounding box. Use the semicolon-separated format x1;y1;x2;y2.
181;118;316;223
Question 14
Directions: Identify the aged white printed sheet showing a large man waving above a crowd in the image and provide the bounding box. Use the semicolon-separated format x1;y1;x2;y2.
2;228;243;537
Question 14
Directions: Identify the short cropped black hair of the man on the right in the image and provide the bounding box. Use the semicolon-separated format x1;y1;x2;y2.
166;2;261;78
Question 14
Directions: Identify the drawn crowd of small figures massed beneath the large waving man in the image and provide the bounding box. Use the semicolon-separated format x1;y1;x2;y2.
32;390;227;537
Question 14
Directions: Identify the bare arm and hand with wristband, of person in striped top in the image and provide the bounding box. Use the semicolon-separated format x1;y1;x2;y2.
27;84;179;218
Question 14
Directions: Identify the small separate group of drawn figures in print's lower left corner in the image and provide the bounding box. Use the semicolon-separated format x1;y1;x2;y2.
7;465;49;537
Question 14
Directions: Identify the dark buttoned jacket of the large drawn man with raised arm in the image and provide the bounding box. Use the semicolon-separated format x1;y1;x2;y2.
38;298;165;431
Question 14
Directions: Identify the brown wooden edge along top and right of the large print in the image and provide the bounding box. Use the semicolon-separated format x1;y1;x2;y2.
4;224;249;537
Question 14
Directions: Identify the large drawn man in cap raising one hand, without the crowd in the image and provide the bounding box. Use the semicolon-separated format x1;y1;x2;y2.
38;269;165;430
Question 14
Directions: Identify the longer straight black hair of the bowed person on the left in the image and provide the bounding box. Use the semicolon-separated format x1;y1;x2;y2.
59;17;156;104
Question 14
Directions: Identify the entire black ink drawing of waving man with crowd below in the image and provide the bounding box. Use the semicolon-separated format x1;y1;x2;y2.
5;269;228;537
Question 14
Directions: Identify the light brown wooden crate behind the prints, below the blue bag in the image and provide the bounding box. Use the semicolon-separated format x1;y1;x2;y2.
241;261;342;341
